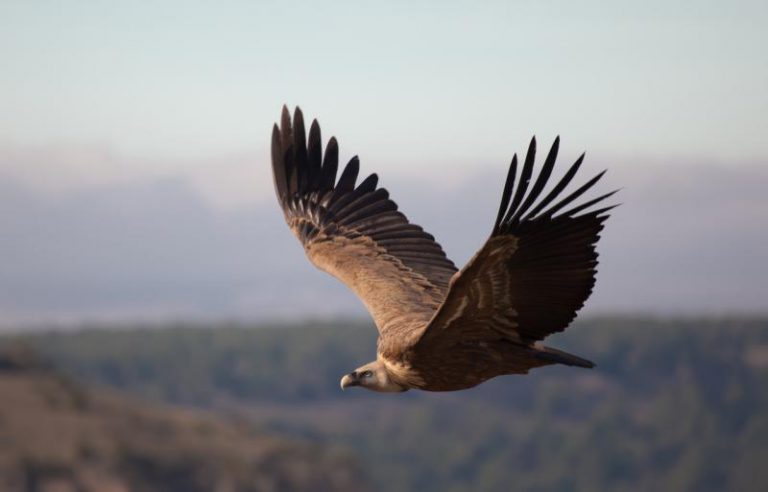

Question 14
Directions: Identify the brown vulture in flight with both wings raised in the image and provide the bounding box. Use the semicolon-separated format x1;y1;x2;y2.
272;106;618;392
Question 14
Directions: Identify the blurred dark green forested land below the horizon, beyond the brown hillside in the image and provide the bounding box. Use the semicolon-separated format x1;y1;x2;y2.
1;318;768;491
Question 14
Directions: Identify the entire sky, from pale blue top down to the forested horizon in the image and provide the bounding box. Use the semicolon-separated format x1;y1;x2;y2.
0;0;768;323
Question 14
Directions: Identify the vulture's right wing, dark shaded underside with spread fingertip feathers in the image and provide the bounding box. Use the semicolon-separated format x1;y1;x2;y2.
417;137;615;350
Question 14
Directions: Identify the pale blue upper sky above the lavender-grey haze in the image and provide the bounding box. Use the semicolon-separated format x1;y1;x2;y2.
0;0;768;172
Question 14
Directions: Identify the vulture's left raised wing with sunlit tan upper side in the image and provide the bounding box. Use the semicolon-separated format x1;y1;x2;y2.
272;107;456;350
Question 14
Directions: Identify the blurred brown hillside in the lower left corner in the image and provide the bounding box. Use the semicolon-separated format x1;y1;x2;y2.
0;347;368;492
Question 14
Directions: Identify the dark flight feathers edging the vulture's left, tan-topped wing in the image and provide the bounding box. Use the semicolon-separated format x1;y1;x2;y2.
272;107;456;297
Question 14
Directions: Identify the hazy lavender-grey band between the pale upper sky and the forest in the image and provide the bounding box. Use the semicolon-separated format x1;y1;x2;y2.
0;160;768;329
